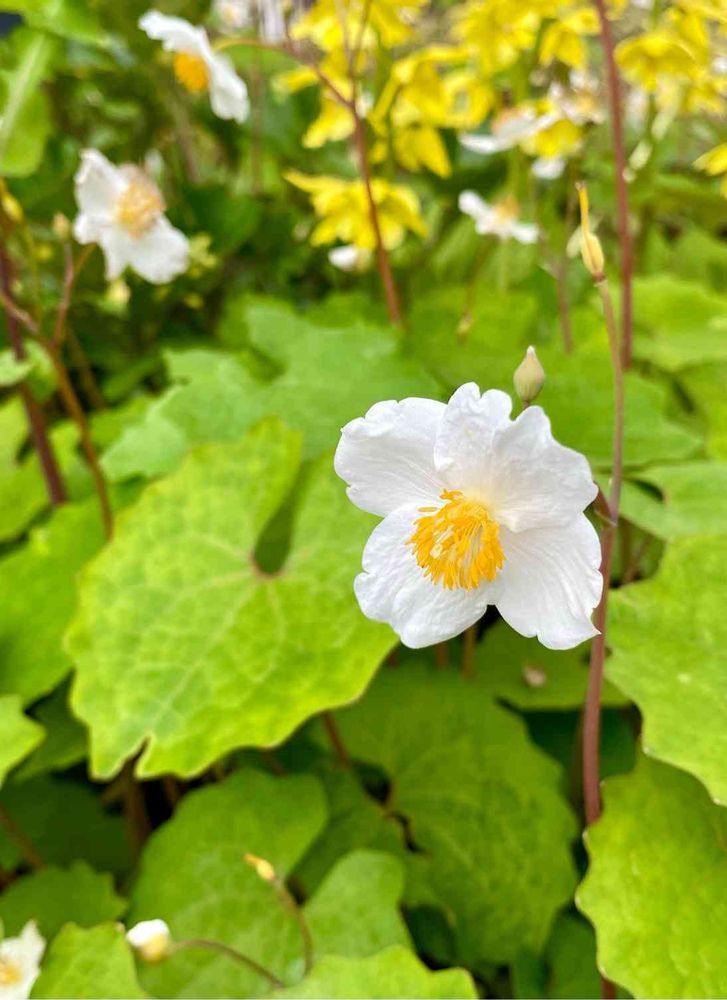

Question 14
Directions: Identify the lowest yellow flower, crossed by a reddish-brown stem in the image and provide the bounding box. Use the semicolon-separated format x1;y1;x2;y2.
285;170;426;250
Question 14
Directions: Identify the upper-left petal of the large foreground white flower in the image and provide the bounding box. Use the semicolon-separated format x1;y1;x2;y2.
333;397;446;517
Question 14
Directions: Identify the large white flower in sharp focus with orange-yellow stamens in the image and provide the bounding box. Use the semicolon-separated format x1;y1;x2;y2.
334;382;602;649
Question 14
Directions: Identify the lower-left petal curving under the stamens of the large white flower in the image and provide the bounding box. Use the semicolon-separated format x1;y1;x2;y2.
354;505;499;649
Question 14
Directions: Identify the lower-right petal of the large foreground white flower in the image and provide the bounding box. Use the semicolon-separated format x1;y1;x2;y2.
494;514;603;649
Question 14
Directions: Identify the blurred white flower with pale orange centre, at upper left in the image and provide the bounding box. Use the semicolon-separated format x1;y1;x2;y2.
73;149;189;284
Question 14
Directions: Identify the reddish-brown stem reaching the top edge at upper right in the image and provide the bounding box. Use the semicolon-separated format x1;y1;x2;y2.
593;0;634;369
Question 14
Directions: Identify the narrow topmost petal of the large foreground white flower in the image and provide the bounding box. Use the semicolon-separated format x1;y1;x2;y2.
434;382;512;492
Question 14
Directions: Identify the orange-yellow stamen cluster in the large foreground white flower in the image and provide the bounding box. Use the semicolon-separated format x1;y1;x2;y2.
408;490;505;590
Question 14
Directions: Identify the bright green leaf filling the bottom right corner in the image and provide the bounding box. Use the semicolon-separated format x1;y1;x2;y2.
578;756;727;997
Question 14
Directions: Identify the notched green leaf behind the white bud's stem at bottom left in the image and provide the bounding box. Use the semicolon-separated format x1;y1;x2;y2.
129;770;326;997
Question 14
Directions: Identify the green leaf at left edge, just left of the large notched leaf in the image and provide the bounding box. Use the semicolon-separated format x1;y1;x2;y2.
0;498;103;702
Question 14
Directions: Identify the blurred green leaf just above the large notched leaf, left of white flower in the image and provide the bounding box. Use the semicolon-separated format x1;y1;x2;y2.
104;305;438;479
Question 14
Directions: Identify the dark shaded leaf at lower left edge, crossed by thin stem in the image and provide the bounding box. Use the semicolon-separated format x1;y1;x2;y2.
0;777;129;873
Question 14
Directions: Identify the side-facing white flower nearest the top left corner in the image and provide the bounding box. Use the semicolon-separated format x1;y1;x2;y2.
139;10;250;122
